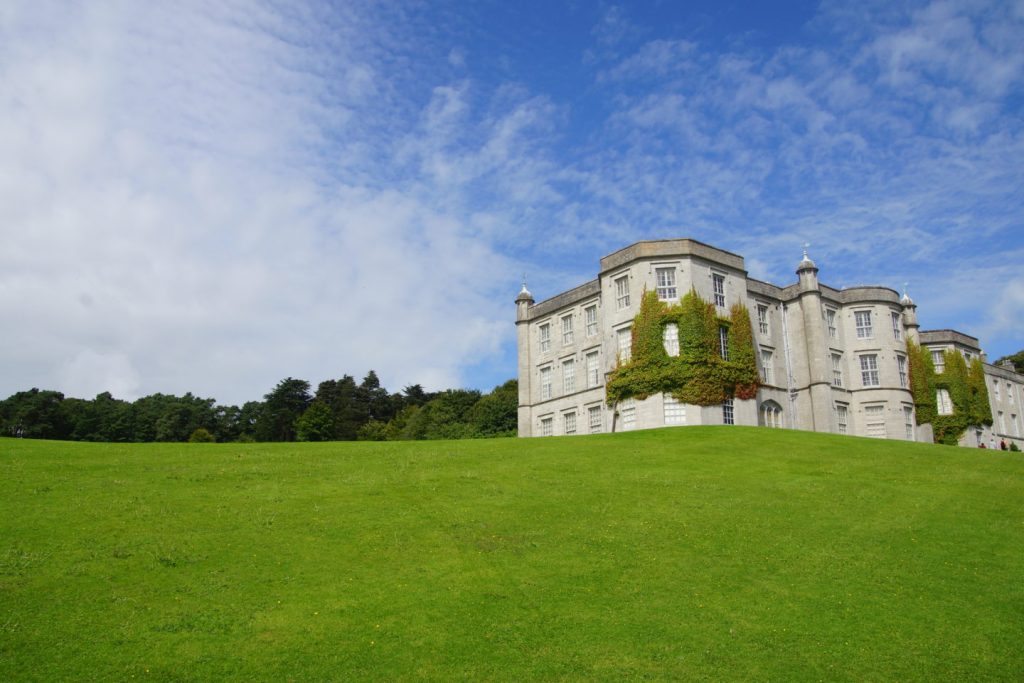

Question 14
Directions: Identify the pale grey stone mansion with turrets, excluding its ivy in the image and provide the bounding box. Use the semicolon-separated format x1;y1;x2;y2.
516;239;1024;446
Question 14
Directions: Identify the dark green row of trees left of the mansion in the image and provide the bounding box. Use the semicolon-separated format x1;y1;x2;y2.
0;370;518;442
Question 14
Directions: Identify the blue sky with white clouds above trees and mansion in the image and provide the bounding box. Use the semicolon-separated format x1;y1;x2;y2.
0;1;1024;402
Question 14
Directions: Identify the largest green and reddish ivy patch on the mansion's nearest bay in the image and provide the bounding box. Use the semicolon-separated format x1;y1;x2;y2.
606;289;760;405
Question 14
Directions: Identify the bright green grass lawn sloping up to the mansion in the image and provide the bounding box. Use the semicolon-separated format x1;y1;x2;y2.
0;427;1024;681
